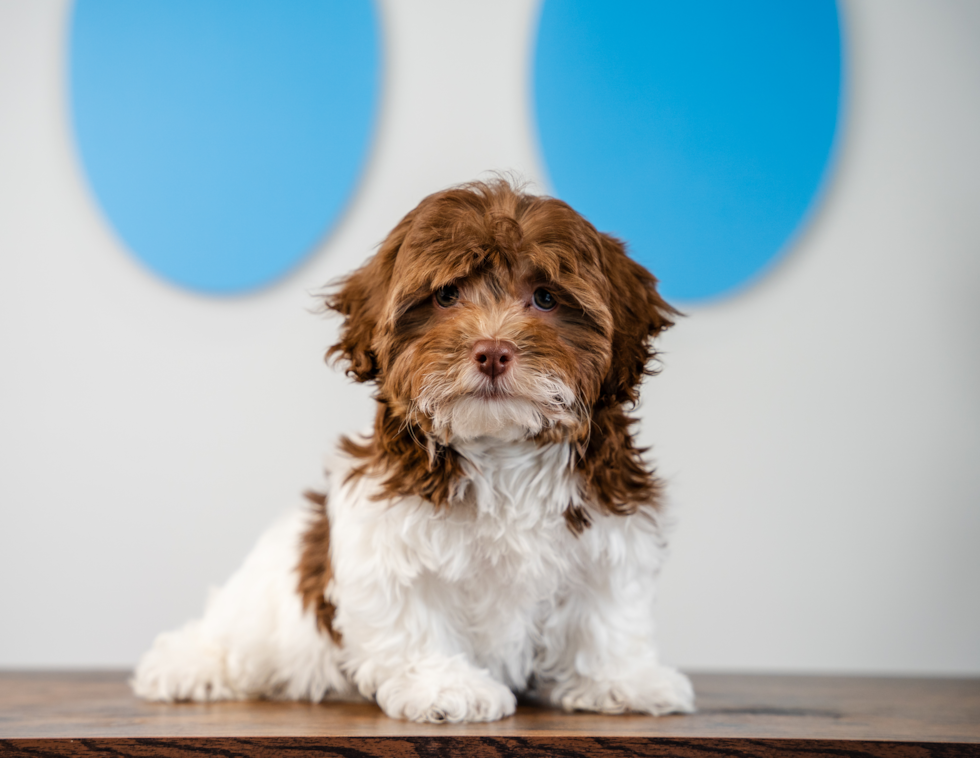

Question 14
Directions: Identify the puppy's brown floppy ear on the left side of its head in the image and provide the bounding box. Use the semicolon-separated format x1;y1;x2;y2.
325;213;414;382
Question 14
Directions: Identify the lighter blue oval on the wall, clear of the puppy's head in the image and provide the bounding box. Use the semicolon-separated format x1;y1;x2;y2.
69;0;380;294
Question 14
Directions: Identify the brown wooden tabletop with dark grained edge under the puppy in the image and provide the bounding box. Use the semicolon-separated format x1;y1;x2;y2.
0;672;980;758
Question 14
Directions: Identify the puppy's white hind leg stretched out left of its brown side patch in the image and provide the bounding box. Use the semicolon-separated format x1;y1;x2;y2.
131;511;351;701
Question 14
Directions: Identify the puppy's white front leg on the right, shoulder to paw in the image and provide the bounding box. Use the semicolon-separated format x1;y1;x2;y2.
538;515;694;715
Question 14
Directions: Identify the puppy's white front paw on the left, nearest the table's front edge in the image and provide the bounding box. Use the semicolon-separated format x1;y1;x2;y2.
375;657;517;723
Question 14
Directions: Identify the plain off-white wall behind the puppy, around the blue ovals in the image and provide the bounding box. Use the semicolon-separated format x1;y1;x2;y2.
0;0;980;674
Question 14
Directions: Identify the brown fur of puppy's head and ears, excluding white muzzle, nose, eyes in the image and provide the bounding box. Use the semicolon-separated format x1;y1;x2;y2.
326;181;677;532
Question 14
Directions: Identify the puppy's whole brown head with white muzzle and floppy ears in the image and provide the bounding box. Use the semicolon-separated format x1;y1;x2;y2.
327;181;676;524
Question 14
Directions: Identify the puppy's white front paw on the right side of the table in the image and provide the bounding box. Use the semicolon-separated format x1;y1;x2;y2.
552;666;694;716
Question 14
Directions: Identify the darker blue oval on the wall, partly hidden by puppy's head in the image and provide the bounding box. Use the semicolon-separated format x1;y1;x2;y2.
534;0;841;301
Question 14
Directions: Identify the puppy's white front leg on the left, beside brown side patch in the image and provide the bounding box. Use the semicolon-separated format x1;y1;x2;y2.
330;504;516;722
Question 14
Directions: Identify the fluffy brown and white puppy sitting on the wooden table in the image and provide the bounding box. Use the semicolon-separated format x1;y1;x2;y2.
132;180;694;722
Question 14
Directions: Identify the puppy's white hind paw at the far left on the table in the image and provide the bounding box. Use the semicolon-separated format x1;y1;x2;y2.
130;621;240;702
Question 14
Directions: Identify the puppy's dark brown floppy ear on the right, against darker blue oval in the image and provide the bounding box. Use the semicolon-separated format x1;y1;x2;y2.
599;234;681;406
